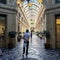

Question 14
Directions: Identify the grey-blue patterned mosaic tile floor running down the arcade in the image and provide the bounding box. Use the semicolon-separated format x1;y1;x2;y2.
0;35;60;60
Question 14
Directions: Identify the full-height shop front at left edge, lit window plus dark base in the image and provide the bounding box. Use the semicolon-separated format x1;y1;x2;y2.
0;14;6;47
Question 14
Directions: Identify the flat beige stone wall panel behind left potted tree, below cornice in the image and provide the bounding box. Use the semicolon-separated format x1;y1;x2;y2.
7;14;18;45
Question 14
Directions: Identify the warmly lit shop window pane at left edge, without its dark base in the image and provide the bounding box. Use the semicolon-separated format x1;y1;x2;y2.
0;15;6;37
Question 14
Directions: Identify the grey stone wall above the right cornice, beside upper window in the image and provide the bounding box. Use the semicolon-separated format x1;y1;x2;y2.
43;0;60;9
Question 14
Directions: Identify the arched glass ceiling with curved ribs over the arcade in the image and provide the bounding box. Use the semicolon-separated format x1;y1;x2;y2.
22;0;42;26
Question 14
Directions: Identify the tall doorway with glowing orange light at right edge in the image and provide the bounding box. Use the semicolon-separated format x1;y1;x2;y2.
56;15;60;48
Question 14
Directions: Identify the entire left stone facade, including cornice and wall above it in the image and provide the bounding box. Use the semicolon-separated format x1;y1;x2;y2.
0;0;18;47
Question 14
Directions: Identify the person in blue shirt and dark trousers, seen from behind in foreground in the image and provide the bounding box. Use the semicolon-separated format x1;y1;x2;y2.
23;29;30;57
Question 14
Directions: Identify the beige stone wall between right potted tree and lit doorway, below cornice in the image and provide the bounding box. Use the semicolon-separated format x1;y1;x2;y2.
46;13;55;48
